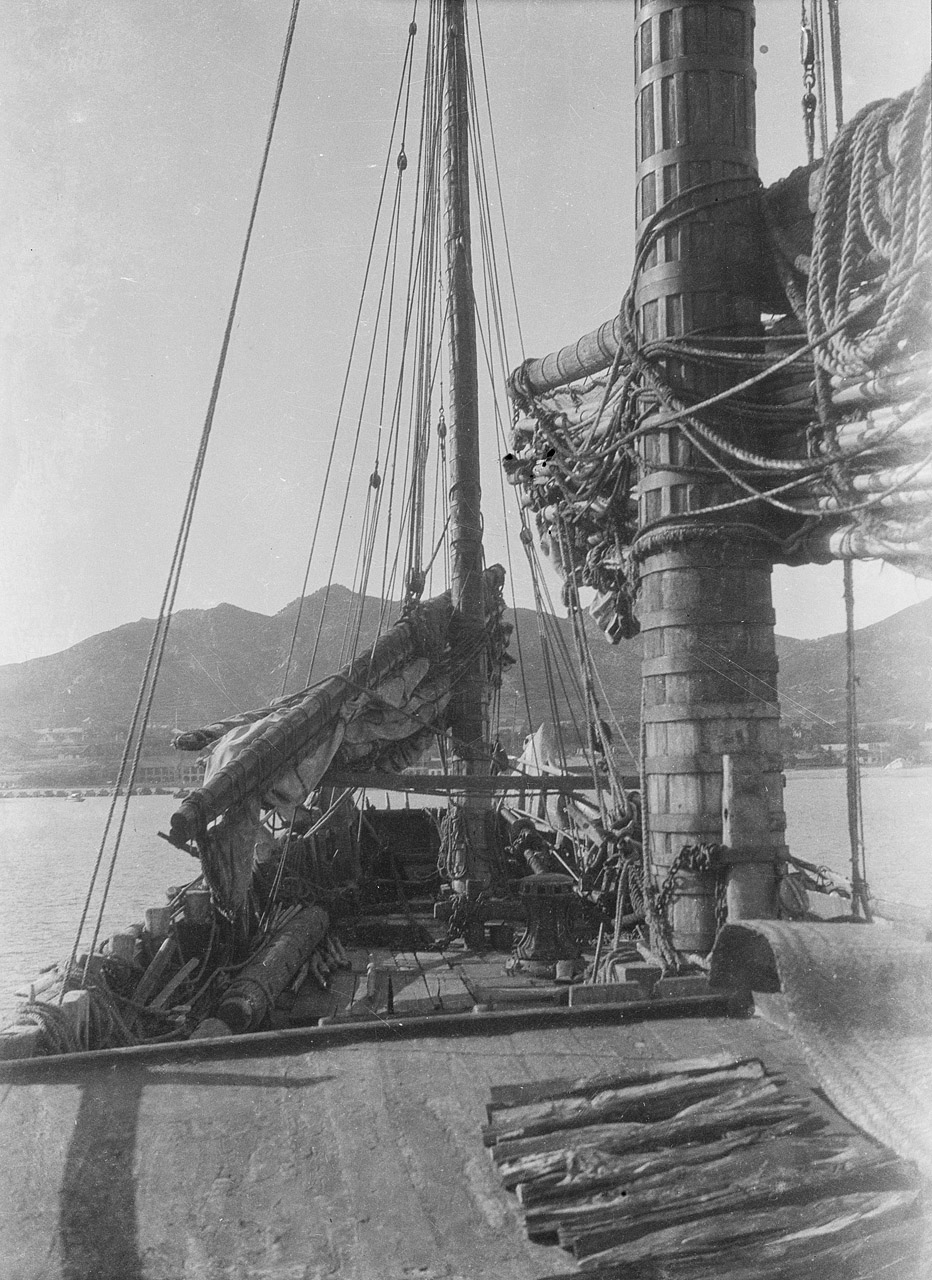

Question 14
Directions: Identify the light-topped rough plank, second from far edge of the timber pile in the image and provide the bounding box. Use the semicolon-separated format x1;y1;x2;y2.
483;1062;764;1147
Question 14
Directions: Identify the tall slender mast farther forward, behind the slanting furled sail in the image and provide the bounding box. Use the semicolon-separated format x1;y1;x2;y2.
443;0;492;892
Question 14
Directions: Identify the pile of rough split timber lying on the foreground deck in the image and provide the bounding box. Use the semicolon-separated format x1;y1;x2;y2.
483;1056;927;1280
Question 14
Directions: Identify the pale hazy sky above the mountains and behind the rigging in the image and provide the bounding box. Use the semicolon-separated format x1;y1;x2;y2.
0;0;929;662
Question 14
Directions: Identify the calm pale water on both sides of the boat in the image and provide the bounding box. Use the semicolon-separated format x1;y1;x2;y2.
0;769;932;1023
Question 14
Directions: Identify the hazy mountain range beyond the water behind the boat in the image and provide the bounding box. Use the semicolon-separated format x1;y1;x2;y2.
0;588;932;742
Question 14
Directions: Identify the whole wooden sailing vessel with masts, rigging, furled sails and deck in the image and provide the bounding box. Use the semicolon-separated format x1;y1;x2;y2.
0;0;932;1280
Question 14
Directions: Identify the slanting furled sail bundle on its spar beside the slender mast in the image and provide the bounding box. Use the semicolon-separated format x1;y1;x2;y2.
170;566;507;910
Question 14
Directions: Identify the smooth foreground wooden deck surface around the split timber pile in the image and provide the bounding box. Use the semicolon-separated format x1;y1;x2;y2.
0;1014;844;1280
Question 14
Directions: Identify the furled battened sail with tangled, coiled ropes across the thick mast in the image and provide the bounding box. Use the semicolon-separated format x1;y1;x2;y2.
503;76;932;640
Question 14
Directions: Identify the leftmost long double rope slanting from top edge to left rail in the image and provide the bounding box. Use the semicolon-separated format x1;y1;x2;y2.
68;0;301;988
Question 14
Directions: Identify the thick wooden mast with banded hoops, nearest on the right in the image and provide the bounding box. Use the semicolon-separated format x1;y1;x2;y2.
635;0;785;951
